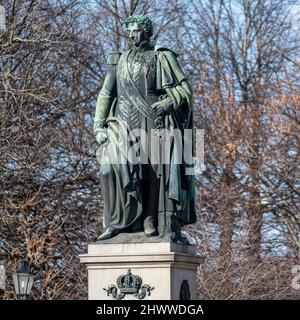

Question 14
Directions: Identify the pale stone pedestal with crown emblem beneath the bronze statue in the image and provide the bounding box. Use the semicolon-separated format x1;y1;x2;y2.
80;242;203;300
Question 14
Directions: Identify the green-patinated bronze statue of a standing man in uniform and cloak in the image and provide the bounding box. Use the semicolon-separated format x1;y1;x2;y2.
94;16;196;242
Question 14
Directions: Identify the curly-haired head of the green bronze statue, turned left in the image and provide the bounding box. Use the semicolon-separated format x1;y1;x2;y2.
125;16;153;47
